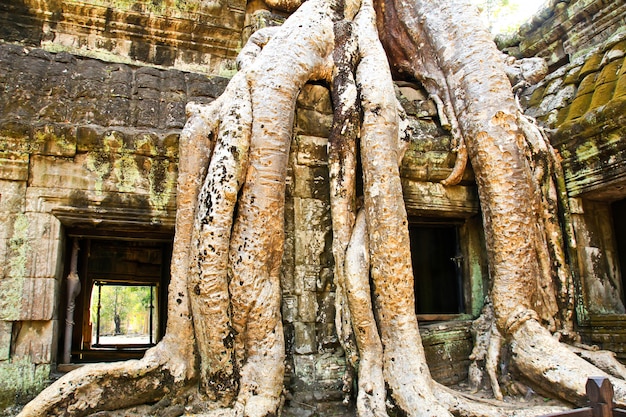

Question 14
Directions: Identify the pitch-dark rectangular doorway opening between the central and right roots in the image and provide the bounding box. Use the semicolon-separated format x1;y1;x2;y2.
409;223;465;320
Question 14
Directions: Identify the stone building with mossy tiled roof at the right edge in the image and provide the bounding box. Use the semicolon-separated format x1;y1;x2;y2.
518;0;626;360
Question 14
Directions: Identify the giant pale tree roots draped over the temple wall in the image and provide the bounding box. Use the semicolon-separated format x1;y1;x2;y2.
15;0;626;417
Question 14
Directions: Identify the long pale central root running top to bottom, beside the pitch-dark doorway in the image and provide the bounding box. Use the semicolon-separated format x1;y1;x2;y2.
355;2;449;416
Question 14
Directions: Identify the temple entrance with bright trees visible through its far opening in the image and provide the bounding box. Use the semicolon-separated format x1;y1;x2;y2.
59;233;172;363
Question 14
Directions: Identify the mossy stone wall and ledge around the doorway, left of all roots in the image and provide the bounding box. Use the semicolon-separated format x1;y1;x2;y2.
0;44;227;404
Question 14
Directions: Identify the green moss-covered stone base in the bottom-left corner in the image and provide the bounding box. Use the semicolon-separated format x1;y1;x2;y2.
0;358;50;410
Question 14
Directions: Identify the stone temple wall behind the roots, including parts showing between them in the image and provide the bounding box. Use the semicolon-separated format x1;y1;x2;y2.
0;44;478;415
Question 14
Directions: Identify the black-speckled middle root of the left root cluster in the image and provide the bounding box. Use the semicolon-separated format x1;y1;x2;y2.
188;74;252;405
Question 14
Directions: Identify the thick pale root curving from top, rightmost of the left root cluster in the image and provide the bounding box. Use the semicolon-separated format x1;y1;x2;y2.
223;1;334;416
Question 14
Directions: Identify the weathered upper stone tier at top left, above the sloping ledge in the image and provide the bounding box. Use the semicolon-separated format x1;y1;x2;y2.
0;0;246;74
